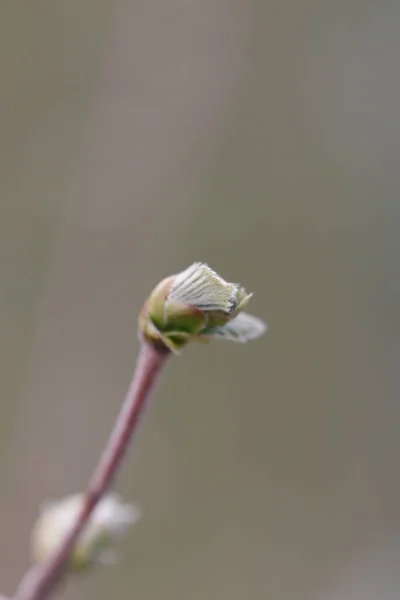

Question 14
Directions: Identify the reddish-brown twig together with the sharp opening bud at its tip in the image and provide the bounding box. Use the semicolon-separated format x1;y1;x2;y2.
9;263;266;600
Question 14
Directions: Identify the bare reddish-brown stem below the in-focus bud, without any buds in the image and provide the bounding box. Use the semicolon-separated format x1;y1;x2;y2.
14;342;168;600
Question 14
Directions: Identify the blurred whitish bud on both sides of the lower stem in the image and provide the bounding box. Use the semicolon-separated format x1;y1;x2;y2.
31;494;140;571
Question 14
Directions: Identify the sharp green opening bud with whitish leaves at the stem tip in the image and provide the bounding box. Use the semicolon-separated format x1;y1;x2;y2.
139;263;266;353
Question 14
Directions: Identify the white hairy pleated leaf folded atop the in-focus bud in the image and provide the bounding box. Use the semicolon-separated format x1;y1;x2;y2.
167;263;239;314
